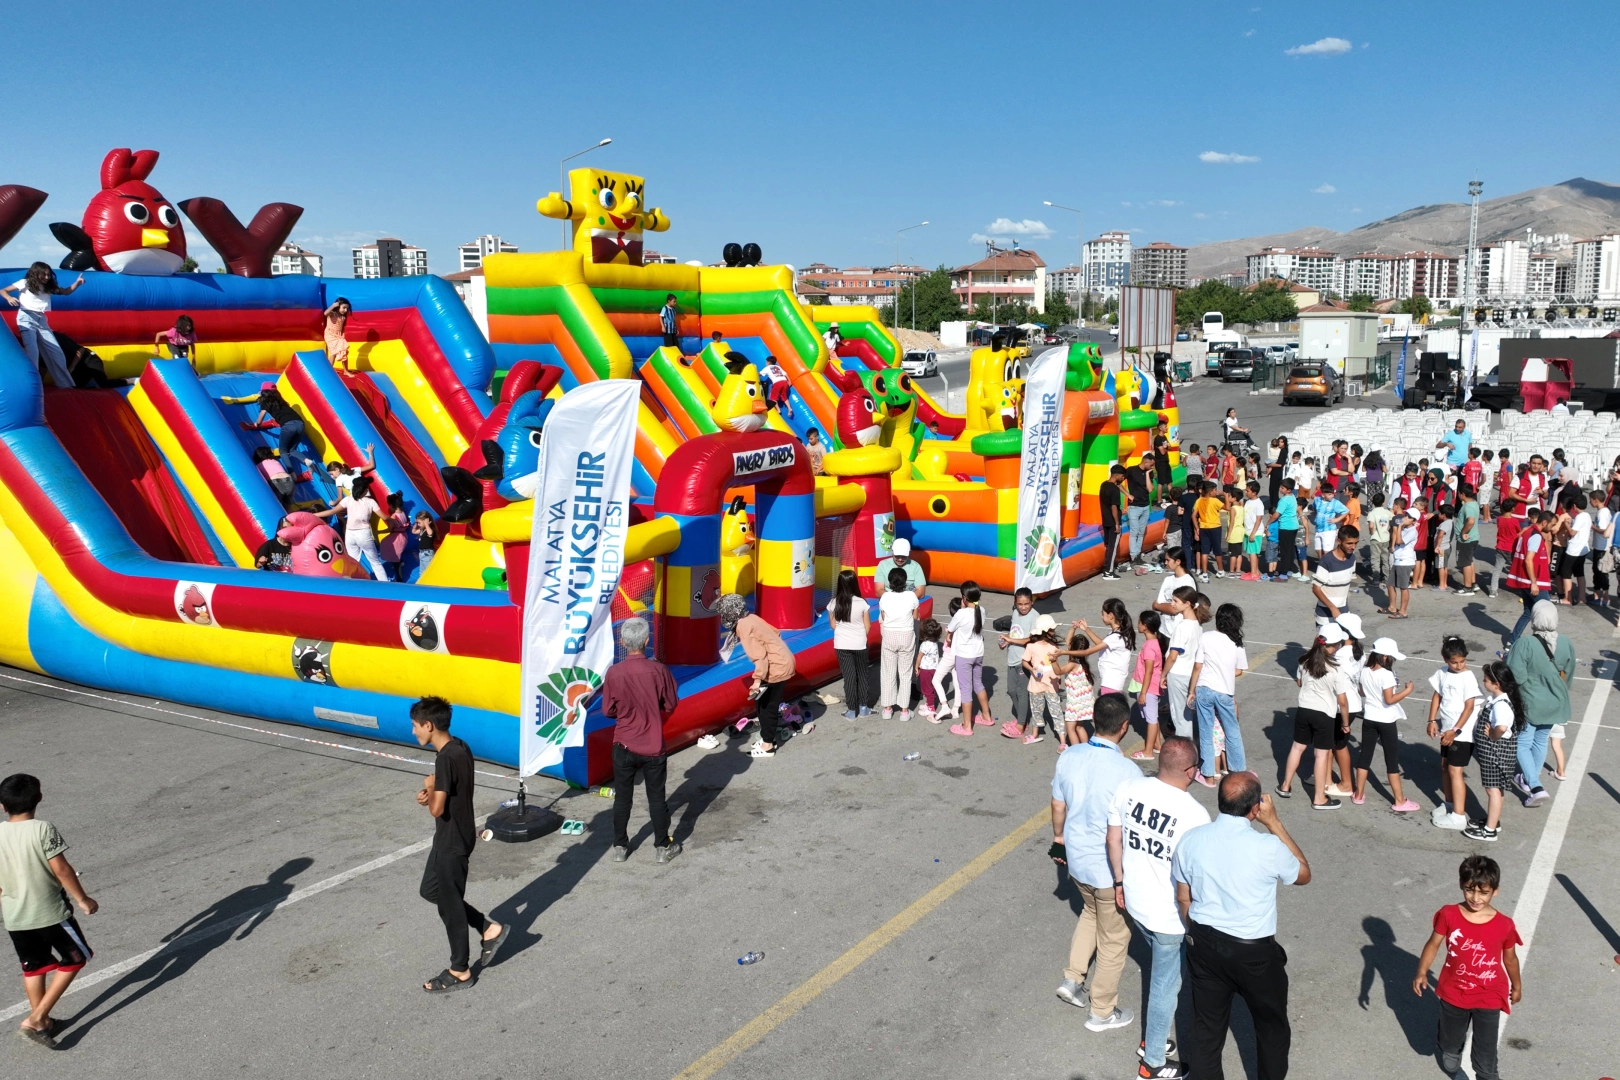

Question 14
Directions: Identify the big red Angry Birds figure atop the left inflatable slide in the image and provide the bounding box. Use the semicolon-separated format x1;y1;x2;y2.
50;147;186;277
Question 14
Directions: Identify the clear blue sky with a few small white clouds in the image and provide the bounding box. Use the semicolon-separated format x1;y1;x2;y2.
12;0;1620;275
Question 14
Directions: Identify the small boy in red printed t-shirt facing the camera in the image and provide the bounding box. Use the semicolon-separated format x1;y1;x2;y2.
1413;855;1524;1080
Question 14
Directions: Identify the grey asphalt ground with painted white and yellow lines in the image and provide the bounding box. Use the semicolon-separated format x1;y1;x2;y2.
0;375;1620;1080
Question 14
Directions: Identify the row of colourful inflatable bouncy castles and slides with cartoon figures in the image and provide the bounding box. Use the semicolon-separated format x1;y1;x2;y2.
0;151;1175;784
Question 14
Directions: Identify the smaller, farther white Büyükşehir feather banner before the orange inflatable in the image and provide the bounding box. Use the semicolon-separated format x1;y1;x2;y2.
1013;348;1069;593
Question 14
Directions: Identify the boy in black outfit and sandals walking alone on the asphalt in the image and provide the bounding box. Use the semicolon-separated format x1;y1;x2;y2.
410;698;498;994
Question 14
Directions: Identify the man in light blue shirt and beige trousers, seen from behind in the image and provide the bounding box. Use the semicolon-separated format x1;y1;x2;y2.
1051;693;1142;1031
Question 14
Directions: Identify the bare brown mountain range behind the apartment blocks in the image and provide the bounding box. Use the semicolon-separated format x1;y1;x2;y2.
1187;176;1620;277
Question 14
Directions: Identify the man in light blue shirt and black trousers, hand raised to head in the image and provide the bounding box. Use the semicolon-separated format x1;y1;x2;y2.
1170;772;1311;1080
